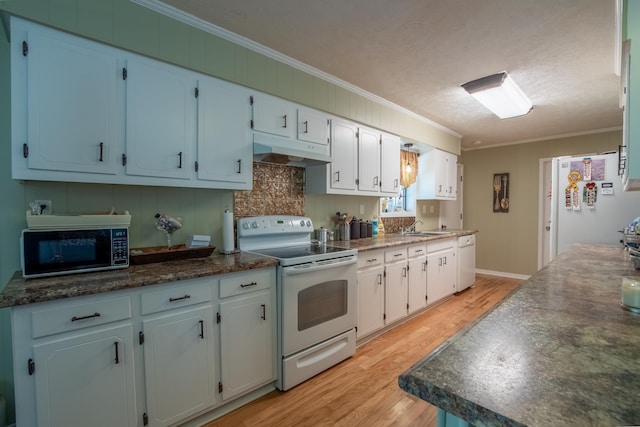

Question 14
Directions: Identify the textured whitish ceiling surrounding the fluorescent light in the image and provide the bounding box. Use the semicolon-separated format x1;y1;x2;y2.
155;0;622;149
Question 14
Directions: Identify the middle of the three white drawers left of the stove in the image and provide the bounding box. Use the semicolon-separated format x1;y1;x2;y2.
141;279;212;315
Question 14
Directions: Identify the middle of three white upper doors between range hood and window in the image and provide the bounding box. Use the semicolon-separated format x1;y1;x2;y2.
358;127;380;194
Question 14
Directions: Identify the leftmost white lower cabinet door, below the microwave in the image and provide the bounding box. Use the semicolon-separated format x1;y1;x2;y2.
33;325;138;427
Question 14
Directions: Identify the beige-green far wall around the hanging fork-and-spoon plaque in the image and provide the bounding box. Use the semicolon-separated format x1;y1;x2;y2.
459;131;622;275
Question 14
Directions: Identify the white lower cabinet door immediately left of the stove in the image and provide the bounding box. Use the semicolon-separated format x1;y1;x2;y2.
220;290;276;400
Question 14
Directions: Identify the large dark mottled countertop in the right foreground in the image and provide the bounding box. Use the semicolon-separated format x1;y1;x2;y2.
398;245;640;426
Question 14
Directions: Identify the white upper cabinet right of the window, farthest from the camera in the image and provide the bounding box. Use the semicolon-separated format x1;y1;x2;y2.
416;149;458;200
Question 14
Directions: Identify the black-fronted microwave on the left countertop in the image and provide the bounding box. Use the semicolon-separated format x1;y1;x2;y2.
20;227;129;278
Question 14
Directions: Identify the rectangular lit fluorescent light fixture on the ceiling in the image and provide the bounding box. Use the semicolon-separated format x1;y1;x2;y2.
462;72;533;119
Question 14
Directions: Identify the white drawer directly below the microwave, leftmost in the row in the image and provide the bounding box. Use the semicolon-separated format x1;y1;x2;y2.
31;296;131;338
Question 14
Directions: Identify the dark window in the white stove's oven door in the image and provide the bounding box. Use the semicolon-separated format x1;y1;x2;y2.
298;280;349;331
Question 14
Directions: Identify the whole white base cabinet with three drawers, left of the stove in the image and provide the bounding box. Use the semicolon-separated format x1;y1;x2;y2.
11;267;276;427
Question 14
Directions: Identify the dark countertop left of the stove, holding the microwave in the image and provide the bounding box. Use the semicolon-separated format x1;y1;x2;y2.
0;252;278;308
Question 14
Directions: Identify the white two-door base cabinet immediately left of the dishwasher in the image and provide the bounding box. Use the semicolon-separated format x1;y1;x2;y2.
427;239;457;304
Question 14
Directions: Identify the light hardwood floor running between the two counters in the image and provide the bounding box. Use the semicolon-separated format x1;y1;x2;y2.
206;274;522;427
